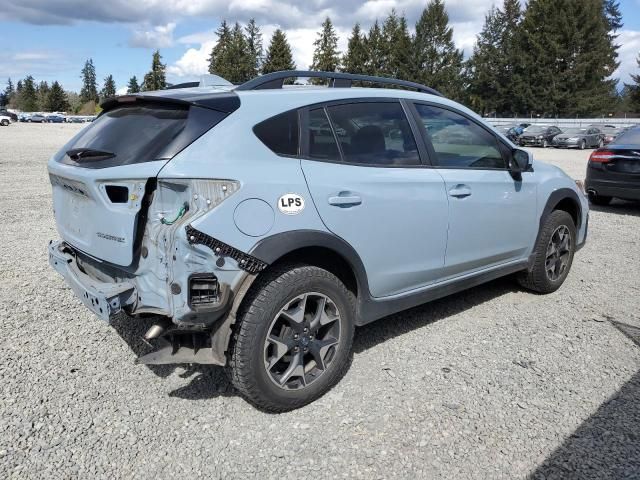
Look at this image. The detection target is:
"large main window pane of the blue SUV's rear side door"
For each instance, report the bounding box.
[327,102,420,166]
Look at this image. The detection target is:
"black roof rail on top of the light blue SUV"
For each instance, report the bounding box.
[236,70,443,97]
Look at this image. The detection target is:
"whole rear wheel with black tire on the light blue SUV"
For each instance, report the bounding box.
[229,264,355,412]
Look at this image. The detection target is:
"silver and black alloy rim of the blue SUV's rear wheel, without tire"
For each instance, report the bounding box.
[264,292,342,390]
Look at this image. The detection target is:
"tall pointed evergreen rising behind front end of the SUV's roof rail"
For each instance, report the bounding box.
[413,0,462,99]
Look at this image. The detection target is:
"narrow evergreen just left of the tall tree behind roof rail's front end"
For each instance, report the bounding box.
[380,9,412,80]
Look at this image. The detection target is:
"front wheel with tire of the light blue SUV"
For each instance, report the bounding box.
[518,210,576,293]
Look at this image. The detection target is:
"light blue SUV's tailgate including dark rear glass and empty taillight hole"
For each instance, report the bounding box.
[49,97,226,266]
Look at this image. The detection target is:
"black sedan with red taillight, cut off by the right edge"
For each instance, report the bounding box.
[585,127,640,205]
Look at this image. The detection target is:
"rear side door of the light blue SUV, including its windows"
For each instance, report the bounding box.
[302,99,447,297]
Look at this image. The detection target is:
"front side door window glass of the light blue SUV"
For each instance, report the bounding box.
[416,105,506,168]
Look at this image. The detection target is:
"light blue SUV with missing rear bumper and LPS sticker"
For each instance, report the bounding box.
[49,72,588,411]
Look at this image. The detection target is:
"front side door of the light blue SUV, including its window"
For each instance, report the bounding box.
[415,103,538,276]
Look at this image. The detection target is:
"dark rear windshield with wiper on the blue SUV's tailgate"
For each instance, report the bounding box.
[57,101,227,168]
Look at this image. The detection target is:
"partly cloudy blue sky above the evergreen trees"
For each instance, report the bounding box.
[0,0,640,93]
